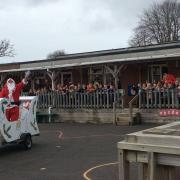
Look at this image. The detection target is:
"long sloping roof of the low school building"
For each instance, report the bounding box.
[0,42,180,72]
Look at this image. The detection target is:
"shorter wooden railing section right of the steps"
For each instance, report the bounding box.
[139,89,180,109]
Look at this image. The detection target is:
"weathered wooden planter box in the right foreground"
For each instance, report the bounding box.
[117,122,180,180]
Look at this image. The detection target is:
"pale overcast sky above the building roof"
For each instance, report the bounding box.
[0,0,167,63]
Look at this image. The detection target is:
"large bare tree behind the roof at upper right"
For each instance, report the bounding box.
[129,0,180,46]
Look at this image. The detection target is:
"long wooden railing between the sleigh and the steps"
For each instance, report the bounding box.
[34,90,123,109]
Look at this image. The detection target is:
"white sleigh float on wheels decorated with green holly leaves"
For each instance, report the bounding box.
[0,96,39,149]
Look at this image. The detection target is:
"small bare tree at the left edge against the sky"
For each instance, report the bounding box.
[0,39,14,57]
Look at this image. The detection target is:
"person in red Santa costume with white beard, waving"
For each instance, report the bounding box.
[0,78,26,121]
